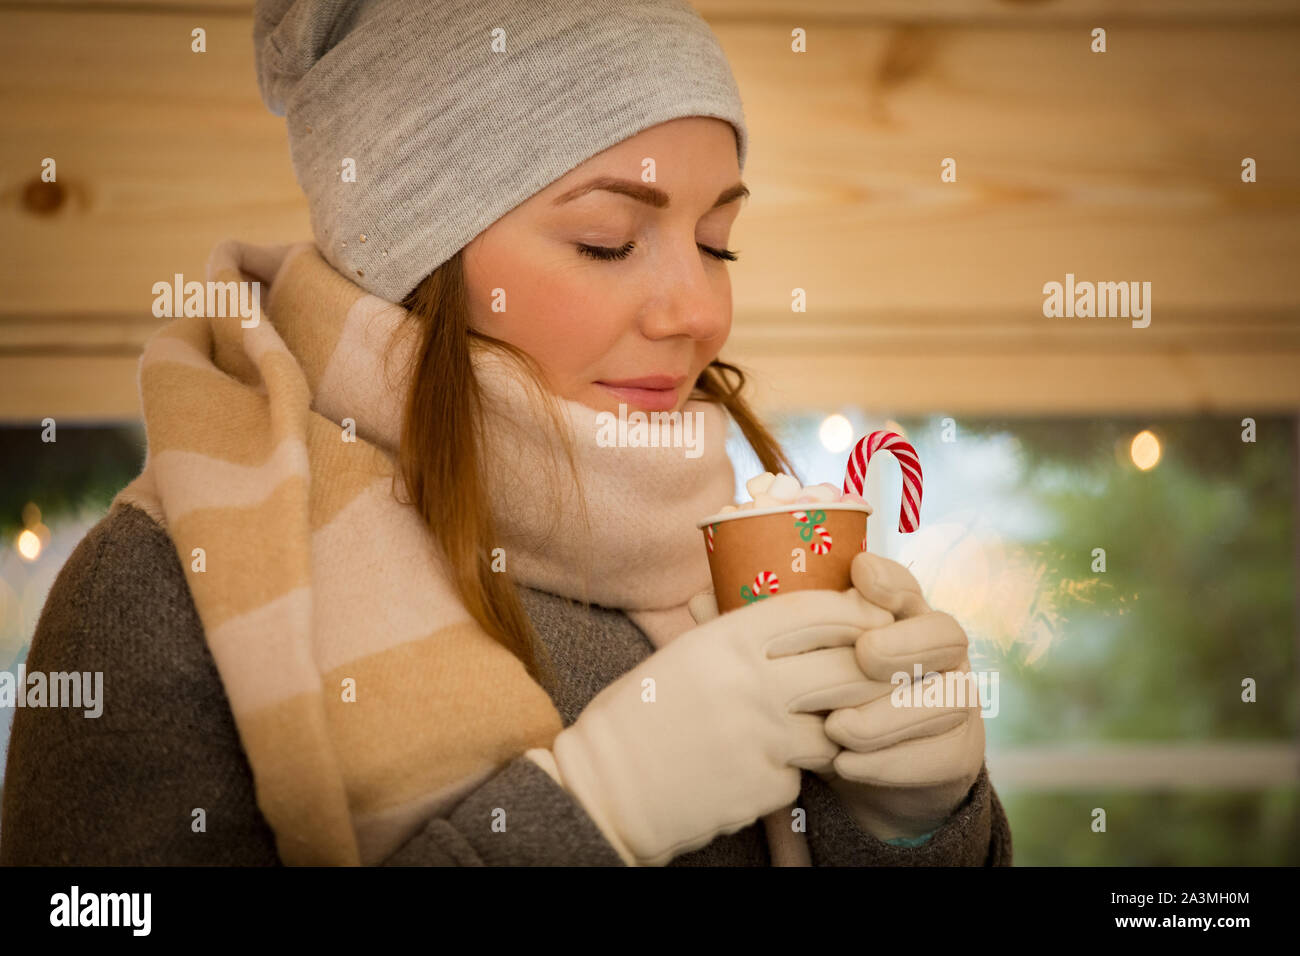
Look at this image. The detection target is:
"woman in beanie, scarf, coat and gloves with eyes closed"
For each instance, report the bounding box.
[0,0,1011,865]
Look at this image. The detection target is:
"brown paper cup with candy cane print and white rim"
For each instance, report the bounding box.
[696,502,871,614]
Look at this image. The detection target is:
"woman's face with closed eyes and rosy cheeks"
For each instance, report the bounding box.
[464,117,748,412]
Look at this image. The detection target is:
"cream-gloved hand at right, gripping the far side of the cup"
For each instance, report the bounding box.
[822,551,984,840]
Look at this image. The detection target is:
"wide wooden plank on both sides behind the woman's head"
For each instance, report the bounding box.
[0,12,1300,313]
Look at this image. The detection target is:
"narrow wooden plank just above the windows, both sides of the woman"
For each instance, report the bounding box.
[0,304,1300,418]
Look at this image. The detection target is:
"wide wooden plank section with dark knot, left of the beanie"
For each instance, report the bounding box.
[0,12,311,315]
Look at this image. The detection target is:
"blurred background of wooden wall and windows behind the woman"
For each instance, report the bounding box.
[0,0,1300,865]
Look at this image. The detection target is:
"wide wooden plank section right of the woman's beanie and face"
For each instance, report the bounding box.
[725,20,1300,312]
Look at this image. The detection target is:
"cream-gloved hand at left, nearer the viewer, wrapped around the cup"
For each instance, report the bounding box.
[528,589,892,866]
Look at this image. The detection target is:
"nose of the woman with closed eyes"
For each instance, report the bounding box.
[641,241,732,339]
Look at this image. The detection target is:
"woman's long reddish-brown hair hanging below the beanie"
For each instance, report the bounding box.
[390,252,794,685]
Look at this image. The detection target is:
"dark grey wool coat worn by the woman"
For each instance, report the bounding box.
[0,507,1011,866]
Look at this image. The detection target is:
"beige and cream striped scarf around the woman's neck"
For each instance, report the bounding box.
[113,242,806,865]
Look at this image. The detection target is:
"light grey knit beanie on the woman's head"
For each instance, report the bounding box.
[254,0,748,302]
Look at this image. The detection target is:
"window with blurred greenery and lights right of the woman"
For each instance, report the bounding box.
[731,410,1300,865]
